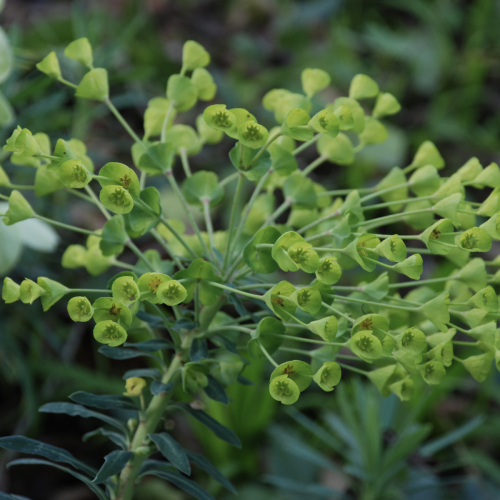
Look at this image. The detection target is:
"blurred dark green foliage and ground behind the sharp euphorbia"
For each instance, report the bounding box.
[0,0,500,500]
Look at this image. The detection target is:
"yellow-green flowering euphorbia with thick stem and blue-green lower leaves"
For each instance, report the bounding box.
[0,38,500,500]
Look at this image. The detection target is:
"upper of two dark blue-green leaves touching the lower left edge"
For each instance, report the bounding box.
[0,436,96,476]
